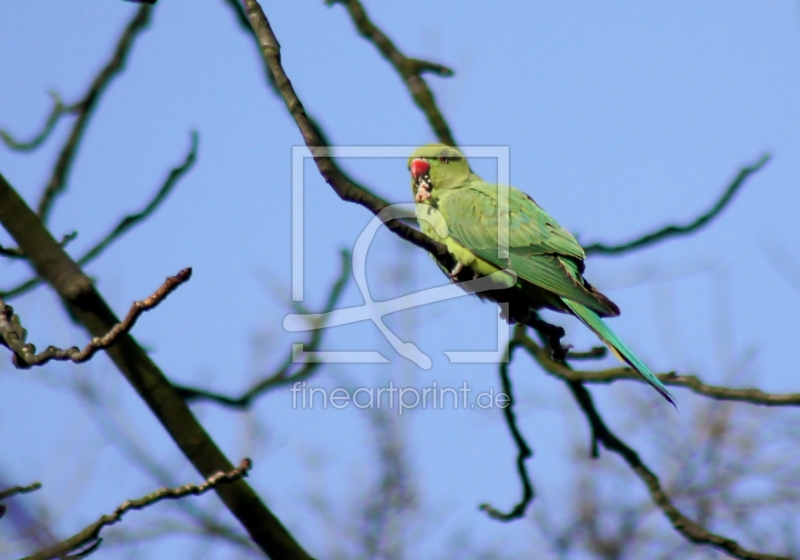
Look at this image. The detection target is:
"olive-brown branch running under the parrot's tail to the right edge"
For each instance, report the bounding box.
[519,334,800,406]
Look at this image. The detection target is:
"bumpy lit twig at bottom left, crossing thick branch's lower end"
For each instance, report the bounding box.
[24,459,253,560]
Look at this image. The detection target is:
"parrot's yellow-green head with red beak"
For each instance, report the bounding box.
[408,144,471,202]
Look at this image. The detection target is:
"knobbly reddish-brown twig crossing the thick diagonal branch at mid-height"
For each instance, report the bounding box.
[0,268,192,369]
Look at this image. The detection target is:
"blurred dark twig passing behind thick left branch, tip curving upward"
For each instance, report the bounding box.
[0,131,198,299]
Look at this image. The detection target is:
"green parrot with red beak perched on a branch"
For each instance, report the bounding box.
[408,144,675,406]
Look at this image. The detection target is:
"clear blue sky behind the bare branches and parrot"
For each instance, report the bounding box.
[0,0,800,559]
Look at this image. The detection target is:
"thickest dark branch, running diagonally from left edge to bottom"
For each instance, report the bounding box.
[0,175,309,559]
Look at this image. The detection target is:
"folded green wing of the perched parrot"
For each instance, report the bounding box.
[437,181,618,315]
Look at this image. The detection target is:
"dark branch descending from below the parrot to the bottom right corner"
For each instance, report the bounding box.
[515,326,789,560]
